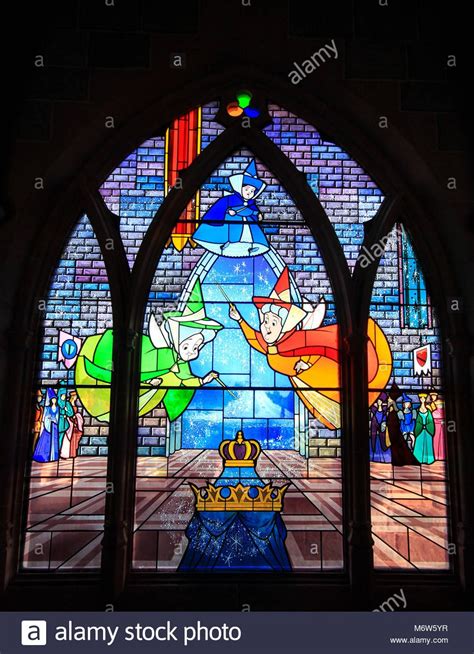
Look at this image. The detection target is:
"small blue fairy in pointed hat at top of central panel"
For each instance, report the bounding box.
[193,160,270,257]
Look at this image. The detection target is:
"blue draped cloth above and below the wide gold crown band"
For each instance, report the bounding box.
[178,468,291,572]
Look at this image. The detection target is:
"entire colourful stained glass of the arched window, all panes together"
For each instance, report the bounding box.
[23,98,447,572]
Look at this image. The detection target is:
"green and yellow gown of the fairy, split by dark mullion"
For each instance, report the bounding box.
[75,329,202,422]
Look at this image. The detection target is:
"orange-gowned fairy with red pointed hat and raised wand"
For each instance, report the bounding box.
[229,267,392,429]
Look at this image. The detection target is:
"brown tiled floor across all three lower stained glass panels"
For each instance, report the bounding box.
[24,450,449,571]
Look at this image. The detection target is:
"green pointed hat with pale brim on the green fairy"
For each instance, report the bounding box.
[163,279,222,347]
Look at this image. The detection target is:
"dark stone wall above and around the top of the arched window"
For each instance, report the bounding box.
[0,0,474,612]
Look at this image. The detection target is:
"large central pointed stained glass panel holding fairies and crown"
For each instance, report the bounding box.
[133,150,343,572]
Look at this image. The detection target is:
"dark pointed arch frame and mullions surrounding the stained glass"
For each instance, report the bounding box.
[0,69,474,610]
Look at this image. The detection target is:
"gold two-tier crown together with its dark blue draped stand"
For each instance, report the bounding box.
[178,431,291,572]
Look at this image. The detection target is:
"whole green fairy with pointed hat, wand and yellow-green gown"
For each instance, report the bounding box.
[75,280,222,422]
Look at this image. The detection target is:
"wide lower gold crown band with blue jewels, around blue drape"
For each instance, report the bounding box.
[189,482,289,511]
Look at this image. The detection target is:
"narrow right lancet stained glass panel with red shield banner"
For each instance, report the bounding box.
[369,225,449,570]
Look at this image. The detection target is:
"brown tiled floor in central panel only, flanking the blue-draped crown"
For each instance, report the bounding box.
[134,450,343,571]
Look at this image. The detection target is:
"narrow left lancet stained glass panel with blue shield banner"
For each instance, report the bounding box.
[22,216,112,570]
